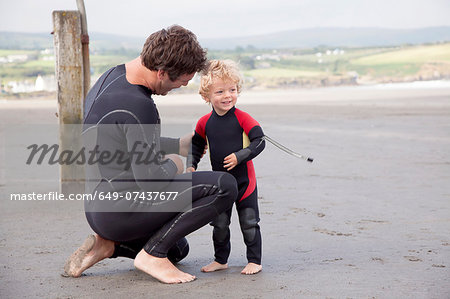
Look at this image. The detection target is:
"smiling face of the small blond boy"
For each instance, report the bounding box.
[205,78,238,115]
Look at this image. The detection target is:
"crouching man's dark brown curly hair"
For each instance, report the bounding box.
[141,25,207,81]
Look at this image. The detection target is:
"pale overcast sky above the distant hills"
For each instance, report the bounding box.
[0,0,450,38]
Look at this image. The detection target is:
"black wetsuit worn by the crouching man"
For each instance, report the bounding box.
[83,65,237,262]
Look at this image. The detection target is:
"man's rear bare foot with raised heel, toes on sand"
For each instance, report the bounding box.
[62,235,114,277]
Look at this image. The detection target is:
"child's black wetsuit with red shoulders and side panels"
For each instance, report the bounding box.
[191,107,265,265]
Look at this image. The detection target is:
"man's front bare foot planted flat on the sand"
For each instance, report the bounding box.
[134,249,195,283]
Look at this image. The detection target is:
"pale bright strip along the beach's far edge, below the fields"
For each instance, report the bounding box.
[0,80,450,109]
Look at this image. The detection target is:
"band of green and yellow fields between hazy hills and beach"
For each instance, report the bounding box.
[0,43,450,87]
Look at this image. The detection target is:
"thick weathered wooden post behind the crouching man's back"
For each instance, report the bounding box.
[53,11,84,194]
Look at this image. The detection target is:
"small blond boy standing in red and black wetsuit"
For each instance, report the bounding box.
[187,60,265,274]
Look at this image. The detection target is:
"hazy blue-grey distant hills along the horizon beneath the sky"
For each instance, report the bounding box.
[0,26,450,51]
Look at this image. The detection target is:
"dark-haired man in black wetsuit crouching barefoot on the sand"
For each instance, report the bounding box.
[64,25,237,283]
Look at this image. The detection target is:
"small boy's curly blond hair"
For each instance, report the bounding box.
[198,59,243,100]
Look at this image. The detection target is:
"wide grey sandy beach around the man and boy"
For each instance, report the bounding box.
[0,83,450,298]
